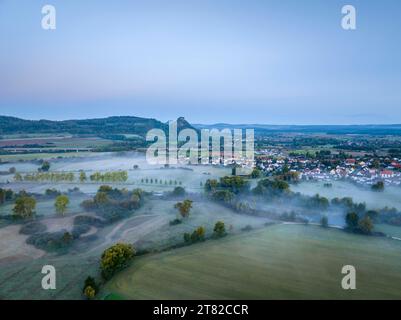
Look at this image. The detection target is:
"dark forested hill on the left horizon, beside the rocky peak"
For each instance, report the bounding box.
[0,116,191,136]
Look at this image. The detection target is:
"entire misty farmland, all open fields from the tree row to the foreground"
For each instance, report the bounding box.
[0,151,401,299]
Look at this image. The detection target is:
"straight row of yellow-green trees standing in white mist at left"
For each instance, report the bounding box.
[14,171,128,182]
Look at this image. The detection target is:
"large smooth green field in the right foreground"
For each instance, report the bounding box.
[104,225,401,299]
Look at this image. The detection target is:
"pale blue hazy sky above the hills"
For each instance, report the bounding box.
[0,0,401,124]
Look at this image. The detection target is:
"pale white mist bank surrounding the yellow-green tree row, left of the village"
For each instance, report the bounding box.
[0,152,231,194]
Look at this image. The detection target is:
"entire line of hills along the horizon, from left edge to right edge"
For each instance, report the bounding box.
[0,116,401,137]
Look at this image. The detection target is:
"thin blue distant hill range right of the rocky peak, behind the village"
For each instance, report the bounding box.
[193,123,401,136]
